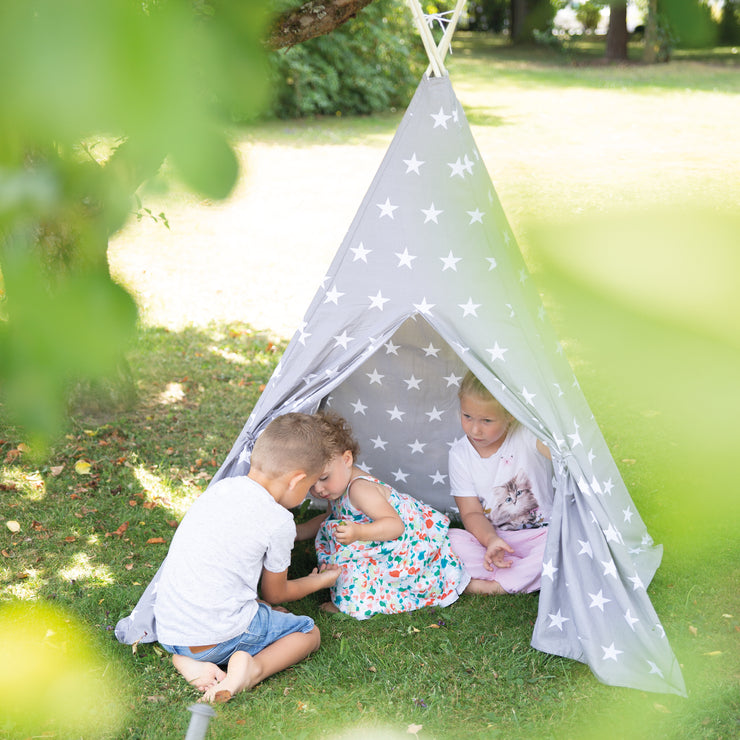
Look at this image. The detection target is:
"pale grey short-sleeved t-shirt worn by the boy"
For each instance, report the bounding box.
[154,476,296,646]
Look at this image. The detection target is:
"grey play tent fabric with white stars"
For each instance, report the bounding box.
[116,76,686,696]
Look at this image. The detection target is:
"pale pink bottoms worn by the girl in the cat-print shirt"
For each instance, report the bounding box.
[448,527,548,594]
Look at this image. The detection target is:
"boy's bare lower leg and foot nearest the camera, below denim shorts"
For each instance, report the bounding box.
[202,627,321,703]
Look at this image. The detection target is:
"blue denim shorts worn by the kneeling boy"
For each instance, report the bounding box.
[160,603,314,665]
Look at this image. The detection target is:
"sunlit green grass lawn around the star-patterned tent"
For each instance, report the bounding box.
[0,34,740,739]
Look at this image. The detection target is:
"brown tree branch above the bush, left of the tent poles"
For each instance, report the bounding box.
[267,0,373,49]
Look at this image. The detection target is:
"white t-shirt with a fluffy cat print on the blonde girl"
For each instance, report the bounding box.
[449,424,553,530]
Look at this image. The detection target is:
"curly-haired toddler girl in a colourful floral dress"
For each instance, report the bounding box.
[311,412,469,619]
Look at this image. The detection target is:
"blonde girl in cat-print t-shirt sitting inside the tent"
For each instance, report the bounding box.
[449,372,553,594]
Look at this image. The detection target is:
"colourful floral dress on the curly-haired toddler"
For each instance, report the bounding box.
[316,476,470,619]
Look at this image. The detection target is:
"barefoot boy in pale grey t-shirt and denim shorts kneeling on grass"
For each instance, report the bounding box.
[154,413,339,703]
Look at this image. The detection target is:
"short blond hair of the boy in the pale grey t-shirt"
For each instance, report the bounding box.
[251,413,330,478]
